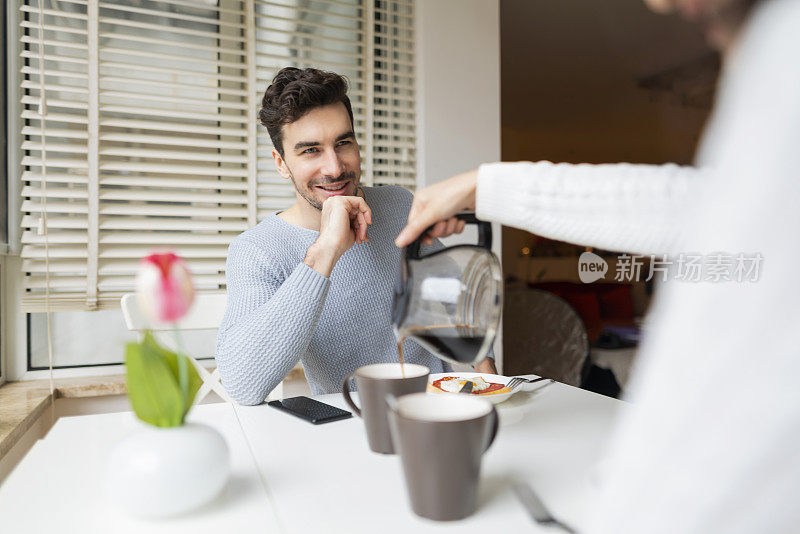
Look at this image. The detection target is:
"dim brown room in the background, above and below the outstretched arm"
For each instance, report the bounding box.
[500,0,720,394]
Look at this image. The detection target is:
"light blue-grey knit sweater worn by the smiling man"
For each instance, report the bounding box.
[216,186,450,404]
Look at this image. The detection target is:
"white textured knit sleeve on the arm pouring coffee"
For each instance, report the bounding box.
[476,162,707,254]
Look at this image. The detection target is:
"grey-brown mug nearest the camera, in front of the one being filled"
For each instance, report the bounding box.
[389,393,499,521]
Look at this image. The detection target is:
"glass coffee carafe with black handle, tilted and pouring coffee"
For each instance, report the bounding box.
[392,213,503,364]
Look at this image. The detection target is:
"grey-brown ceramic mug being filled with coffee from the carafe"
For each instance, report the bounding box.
[342,363,431,454]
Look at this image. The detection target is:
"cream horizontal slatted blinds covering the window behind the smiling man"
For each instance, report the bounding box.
[20,0,416,311]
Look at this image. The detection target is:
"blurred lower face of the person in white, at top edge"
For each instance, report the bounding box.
[645,0,756,50]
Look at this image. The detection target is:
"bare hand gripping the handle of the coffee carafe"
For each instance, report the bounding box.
[395,170,478,247]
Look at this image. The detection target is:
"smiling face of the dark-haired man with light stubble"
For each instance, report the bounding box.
[272,102,361,210]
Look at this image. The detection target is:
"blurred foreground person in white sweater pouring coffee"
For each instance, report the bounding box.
[397,0,800,534]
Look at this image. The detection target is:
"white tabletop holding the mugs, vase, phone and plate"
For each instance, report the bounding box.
[0,378,623,534]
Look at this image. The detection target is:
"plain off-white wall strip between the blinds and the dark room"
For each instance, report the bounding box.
[416,0,502,365]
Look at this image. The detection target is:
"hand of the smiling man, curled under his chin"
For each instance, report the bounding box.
[303,196,372,278]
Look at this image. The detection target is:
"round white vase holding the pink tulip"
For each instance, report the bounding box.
[106,423,230,517]
